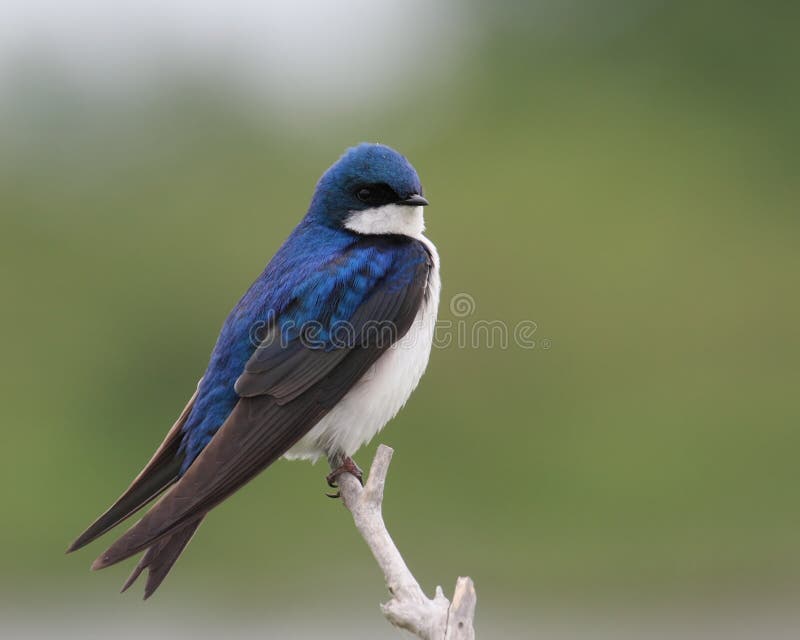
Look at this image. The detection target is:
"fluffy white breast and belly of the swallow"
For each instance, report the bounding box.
[284,237,441,462]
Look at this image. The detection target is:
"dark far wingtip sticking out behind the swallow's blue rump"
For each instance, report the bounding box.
[67,391,197,553]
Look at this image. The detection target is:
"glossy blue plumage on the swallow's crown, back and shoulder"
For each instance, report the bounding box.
[181,144,425,473]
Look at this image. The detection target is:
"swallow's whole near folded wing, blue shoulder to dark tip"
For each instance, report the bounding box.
[89,236,431,568]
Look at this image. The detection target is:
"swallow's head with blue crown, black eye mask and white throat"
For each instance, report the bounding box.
[309,143,428,237]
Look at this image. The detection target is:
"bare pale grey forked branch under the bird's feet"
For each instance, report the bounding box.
[330,445,477,640]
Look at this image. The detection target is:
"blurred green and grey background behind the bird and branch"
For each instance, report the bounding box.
[0,0,800,638]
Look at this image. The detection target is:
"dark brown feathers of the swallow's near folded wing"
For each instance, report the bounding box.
[93,252,430,569]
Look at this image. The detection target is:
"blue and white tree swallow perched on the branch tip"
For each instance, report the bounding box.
[68,143,441,598]
